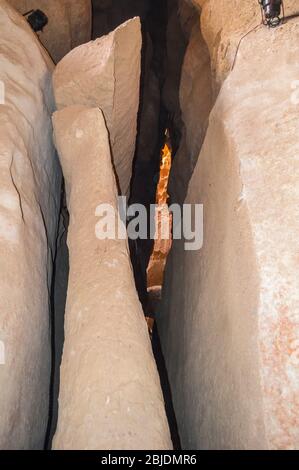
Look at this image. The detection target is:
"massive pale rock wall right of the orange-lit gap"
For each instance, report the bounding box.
[159,0,299,449]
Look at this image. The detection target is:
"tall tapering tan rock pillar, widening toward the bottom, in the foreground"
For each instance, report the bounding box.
[53,106,171,450]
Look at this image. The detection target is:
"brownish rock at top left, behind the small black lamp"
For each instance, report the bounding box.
[9,0,91,62]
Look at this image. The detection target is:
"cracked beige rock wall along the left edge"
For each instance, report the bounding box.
[0,0,60,449]
